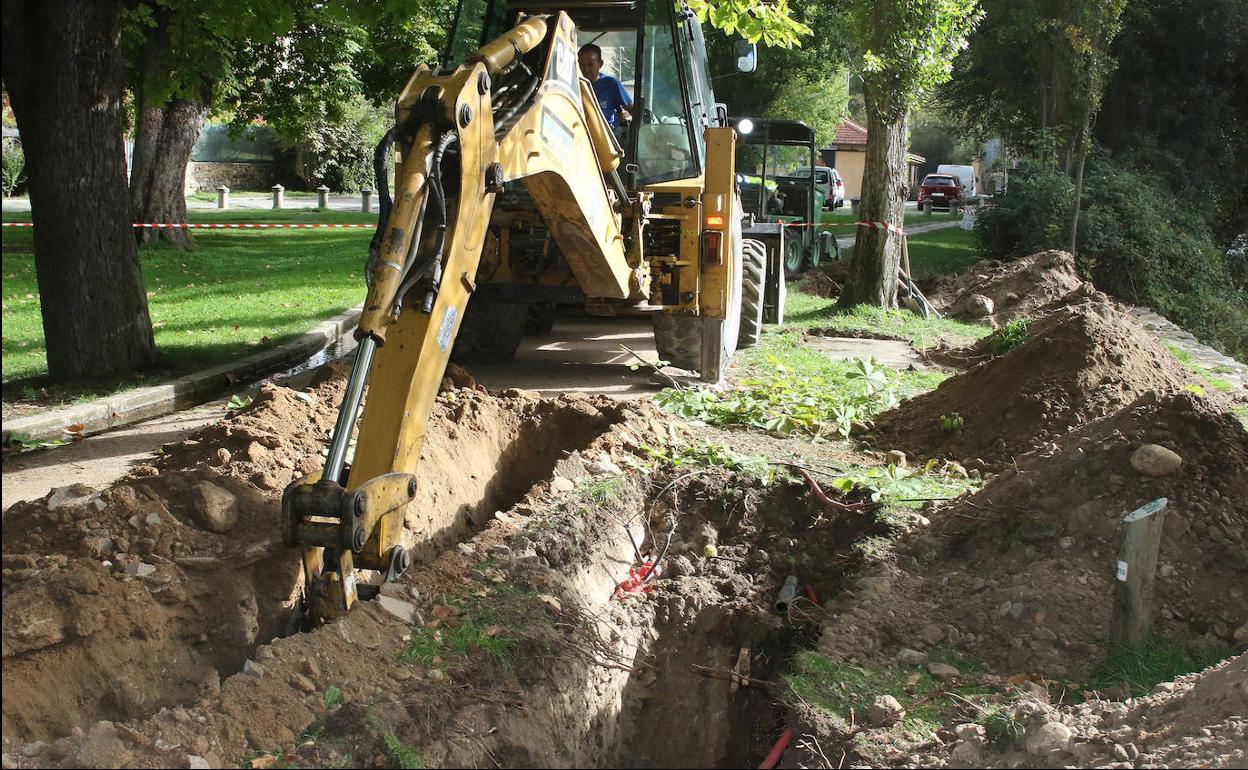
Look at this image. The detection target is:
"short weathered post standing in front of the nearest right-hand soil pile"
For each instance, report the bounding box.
[1109,498,1167,649]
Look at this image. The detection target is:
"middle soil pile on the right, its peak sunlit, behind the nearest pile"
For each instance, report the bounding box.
[872,301,1187,465]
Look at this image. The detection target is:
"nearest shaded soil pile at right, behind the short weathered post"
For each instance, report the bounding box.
[821,393,1248,681]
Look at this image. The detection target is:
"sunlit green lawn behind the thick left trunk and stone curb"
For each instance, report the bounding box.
[2,210,377,402]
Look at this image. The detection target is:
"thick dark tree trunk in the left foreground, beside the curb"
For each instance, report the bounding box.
[4,0,156,382]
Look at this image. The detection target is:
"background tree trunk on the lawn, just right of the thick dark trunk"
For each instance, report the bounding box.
[130,99,208,248]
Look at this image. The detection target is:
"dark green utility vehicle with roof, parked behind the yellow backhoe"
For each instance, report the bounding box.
[730,117,840,318]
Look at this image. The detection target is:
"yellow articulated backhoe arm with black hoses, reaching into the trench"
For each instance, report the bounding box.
[282,12,643,621]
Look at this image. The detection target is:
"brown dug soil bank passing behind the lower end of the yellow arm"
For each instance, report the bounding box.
[2,372,661,761]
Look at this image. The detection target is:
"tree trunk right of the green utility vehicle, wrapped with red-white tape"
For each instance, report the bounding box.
[839,84,906,308]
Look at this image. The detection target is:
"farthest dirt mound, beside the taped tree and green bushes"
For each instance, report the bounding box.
[931,251,1096,323]
